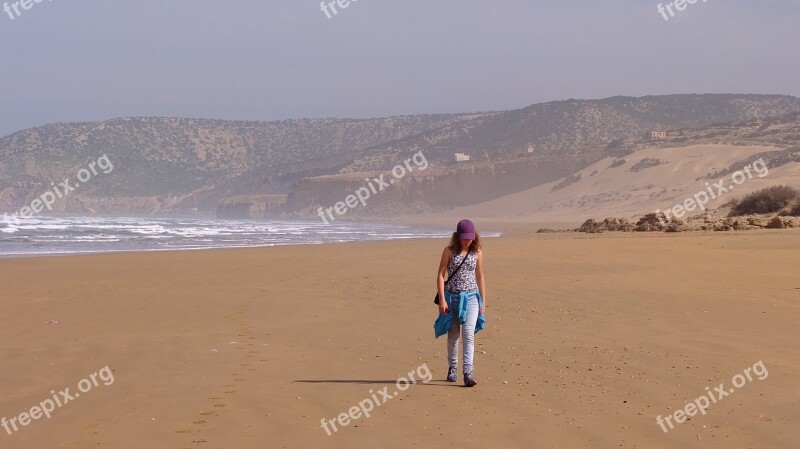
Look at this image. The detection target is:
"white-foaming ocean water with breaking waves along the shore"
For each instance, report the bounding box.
[0,217,462,258]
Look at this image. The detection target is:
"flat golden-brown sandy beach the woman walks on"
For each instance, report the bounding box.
[0,228,800,449]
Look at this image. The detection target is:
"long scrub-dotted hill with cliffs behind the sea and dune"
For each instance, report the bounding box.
[0,94,800,216]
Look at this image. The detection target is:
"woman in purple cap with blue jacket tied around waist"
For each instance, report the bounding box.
[436,220,486,387]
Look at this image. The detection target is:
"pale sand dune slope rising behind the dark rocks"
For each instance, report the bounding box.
[446,145,800,222]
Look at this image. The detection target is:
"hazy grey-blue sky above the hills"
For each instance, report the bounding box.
[0,0,800,135]
